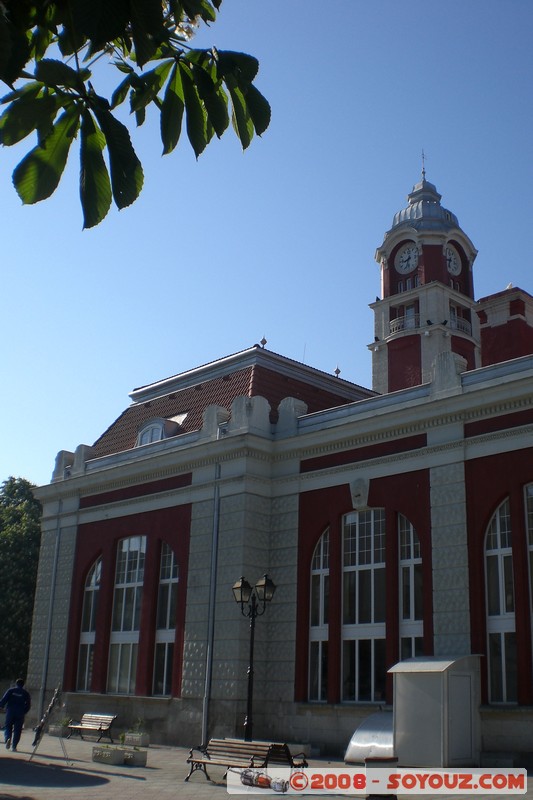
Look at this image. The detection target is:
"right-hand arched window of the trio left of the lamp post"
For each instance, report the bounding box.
[152,543,179,695]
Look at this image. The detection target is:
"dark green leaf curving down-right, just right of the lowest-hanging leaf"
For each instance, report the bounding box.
[95,109,144,208]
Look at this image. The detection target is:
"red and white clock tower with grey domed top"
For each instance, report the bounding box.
[369,170,481,394]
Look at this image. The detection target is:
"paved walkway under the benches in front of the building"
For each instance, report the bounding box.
[0,731,533,800]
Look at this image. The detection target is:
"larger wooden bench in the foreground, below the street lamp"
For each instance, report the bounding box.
[185,739,307,781]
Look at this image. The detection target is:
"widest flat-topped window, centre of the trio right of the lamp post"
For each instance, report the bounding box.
[342,509,386,701]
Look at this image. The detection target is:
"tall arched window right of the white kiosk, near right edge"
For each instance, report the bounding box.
[485,500,517,703]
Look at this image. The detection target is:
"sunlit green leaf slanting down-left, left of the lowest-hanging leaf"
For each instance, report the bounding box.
[13,104,80,205]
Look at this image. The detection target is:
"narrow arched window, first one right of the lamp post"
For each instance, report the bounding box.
[309,528,329,701]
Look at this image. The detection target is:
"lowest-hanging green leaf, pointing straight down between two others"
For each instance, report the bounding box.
[80,110,112,229]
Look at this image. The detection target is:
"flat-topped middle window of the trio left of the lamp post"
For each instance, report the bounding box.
[107,536,146,694]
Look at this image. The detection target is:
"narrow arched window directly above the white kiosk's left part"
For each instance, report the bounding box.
[398,514,423,660]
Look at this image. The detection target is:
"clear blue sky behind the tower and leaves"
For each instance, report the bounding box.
[0,0,533,484]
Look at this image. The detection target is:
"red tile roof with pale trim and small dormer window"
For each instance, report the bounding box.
[92,347,373,458]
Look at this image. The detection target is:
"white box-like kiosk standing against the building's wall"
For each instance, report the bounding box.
[389,655,481,767]
